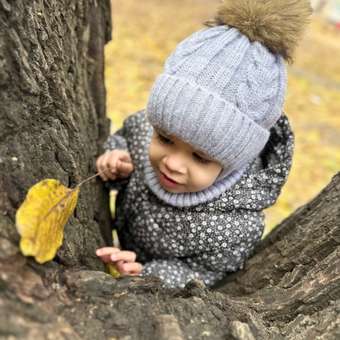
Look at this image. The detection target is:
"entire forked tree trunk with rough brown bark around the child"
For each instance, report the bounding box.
[0,0,340,340]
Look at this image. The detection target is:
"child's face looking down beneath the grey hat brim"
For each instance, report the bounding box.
[149,128,222,193]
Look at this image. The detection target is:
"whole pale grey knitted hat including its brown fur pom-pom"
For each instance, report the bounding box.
[147,0,311,181]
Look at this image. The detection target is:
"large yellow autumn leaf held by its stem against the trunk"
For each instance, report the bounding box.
[16,179,79,263]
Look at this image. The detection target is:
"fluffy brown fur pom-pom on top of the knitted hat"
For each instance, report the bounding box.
[205,0,312,61]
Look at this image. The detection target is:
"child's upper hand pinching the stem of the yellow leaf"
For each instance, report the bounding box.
[96,149,134,181]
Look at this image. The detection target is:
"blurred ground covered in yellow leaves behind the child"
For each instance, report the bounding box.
[105,0,340,236]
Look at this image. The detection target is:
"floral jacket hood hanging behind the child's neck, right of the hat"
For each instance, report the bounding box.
[214,114,294,210]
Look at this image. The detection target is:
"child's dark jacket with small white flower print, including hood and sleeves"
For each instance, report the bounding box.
[106,111,294,287]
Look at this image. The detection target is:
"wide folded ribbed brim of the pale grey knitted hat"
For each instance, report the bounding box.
[147,73,269,180]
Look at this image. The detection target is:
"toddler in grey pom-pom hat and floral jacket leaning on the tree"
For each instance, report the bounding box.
[96,0,311,287]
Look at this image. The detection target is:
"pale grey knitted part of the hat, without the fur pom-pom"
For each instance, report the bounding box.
[147,26,286,185]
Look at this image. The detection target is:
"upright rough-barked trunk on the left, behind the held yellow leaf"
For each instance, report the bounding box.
[0,0,111,269]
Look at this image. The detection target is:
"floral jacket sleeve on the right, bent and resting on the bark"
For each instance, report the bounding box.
[142,209,264,288]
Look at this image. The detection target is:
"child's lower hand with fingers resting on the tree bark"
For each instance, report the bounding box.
[96,247,143,276]
